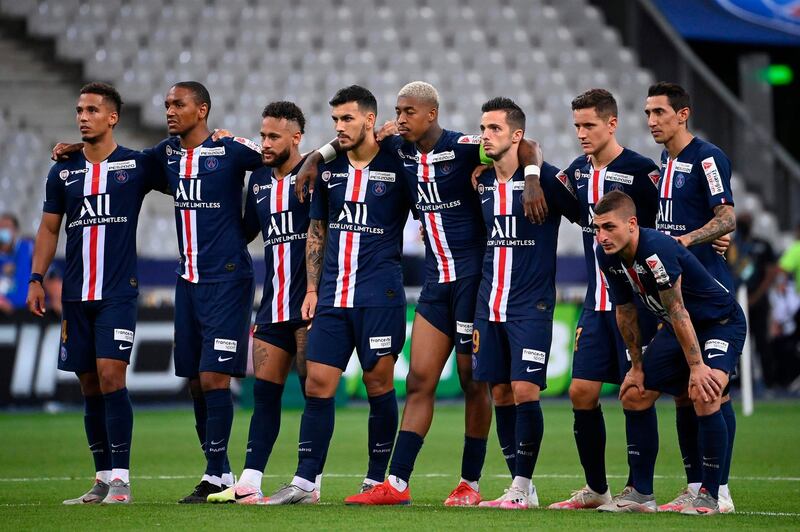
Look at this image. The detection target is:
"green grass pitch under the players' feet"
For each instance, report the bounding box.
[0,399,800,531]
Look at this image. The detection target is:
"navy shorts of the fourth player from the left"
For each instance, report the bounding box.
[306,305,406,371]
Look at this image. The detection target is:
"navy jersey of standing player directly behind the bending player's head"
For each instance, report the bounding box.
[562,148,659,310]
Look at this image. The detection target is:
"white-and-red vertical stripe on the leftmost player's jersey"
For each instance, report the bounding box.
[81,161,111,301]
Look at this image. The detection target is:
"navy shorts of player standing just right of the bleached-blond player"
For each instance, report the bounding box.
[472,319,553,390]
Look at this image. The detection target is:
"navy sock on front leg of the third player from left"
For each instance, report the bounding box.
[244,379,283,473]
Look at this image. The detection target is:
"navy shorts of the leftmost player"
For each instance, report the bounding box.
[58,297,136,373]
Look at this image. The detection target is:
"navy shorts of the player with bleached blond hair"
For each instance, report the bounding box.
[417,275,481,355]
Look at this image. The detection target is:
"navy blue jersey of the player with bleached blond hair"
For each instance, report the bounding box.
[384,130,486,283]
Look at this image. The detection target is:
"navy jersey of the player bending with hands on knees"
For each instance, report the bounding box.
[596,227,737,325]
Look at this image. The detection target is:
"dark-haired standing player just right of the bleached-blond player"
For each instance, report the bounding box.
[473,98,578,510]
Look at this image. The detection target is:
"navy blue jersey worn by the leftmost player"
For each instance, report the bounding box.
[44,146,166,301]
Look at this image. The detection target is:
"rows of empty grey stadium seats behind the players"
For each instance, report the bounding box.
[0,0,775,256]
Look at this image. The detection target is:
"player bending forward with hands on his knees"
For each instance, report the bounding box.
[594,191,746,515]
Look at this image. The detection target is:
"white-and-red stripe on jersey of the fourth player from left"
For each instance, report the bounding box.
[333,166,369,308]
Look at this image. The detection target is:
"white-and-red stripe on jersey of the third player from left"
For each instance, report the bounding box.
[269,175,292,323]
